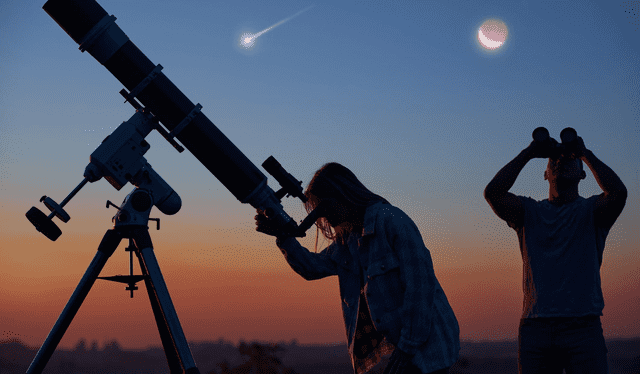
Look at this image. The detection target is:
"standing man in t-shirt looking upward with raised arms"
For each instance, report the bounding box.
[484,133,627,374]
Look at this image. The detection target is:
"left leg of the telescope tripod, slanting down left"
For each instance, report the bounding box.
[27,230,122,374]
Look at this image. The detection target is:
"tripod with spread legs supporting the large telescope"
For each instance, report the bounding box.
[27,225,200,374]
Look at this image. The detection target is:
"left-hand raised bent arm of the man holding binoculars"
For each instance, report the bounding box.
[484,143,540,226]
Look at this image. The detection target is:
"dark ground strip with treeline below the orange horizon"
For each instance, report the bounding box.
[0,339,640,374]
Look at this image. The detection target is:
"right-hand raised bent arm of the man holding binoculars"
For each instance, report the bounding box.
[578,142,627,228]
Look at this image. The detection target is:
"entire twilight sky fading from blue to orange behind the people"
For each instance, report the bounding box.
[0,0,640,348]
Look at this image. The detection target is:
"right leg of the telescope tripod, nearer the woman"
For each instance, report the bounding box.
[134,227,200,374]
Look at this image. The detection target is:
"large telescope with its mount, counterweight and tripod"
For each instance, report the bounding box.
[26,0,323,374]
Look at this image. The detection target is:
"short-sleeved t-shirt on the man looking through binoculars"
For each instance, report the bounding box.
[509,196,609,318]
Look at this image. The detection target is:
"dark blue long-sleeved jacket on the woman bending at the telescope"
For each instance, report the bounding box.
[276,203,460,373]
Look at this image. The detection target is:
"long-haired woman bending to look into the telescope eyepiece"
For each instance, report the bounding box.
[255,162,460,374]
